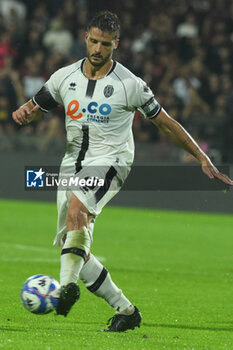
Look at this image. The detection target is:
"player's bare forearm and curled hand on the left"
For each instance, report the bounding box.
[12,100,43,125]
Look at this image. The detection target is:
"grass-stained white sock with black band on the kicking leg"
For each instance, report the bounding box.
[60,228,91,285]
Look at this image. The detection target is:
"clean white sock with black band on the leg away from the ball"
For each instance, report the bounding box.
[79,254,134,315]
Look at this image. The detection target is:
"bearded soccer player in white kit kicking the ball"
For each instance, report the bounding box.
[13,11,233,332]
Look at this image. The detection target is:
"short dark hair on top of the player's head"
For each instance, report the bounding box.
[87,11,120,39]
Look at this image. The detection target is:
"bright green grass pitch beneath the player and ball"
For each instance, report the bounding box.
[0,200,233,350]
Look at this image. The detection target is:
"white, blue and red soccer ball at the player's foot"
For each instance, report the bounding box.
[21,275,60,314]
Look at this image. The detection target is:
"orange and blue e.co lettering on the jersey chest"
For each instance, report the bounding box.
[66,100,112,120]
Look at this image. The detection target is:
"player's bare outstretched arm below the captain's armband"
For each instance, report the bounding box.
[151,108,233,185]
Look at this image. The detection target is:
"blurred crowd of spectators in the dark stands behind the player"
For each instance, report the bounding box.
[0,0,233,162]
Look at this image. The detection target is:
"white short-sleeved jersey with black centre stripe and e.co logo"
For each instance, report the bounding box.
[33,59,161,165]
